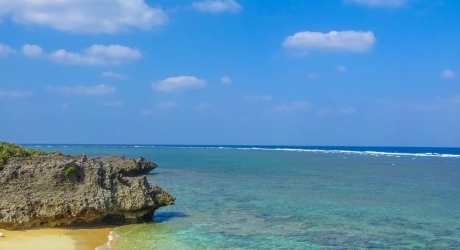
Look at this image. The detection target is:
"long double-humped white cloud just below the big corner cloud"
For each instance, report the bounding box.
[49,44,142,65]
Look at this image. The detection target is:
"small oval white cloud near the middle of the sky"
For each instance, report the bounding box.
[152,76,206,93]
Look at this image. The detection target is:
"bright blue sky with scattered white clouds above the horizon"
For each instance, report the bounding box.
[0,0,460,147]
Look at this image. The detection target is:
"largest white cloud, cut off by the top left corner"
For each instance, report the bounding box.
[0,0,167,33]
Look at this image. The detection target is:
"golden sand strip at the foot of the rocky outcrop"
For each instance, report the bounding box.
[0,228,113,250]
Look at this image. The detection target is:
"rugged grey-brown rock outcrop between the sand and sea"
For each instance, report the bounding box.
[0,153,174,229]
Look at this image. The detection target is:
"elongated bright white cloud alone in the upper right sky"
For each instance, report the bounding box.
[283,30,376,53]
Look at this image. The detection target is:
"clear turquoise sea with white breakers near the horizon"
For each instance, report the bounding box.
[24,144,460,250]
